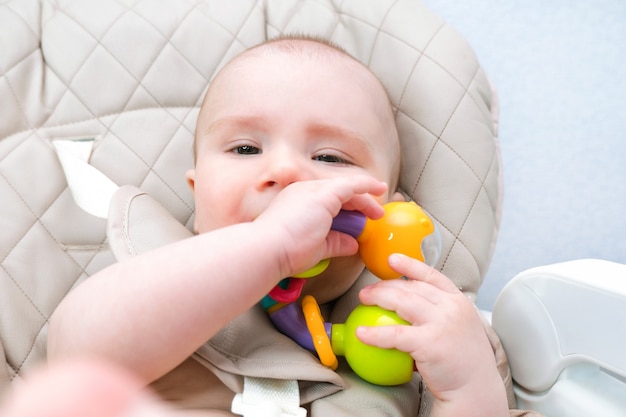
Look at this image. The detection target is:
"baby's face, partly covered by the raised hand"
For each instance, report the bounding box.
[189,45,399,302]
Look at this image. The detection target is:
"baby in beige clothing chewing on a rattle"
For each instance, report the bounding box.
[48,37,509,416]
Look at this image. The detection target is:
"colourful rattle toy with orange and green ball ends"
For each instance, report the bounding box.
[261,202,441,385]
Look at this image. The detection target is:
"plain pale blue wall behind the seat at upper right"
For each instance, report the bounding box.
[423,0,626,310]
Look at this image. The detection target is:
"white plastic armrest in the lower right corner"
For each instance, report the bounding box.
[492,259,626,417]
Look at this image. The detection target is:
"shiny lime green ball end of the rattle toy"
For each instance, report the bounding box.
[331,305,414,386]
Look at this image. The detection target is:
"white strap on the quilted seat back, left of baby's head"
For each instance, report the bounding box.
[52,138,119,219]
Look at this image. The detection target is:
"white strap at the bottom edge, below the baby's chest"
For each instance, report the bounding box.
[231,377,307,417]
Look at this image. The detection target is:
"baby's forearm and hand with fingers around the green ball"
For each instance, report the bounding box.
[357,255,509,417]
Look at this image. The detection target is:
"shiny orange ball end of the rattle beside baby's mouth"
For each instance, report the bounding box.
[357,202,435,279]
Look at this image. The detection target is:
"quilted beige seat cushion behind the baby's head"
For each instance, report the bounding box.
[0,0,501,386]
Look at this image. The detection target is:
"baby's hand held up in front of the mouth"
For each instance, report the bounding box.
[256,175,387,276]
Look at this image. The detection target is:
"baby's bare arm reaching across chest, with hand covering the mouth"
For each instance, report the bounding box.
[48,176,386,382]
